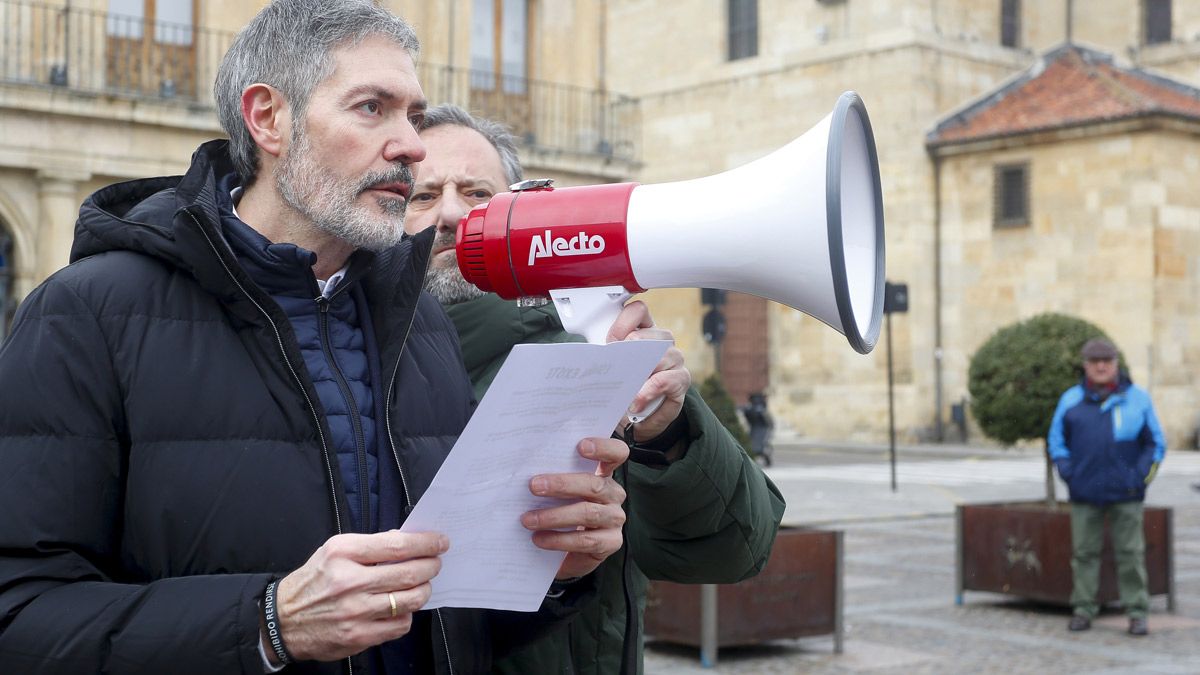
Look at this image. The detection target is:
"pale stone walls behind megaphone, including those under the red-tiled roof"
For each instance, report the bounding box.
[608,0,1200,447]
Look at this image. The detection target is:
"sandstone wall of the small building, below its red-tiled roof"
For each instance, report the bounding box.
[942,126,1200,447]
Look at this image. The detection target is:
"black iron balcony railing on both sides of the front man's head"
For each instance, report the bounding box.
[0,0,641,161]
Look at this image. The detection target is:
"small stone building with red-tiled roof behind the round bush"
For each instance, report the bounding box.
[928,46,1200,447]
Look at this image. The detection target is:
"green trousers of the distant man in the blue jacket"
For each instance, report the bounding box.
[1070,502,1150,619]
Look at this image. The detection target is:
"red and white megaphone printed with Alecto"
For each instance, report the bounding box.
[456,91,884,354]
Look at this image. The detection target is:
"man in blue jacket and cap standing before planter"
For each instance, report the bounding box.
[1049,338,1166,635]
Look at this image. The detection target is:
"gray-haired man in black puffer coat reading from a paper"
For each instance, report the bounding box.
[0,0,628,675]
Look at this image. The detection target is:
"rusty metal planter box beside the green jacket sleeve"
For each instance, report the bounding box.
[646,527,842,652]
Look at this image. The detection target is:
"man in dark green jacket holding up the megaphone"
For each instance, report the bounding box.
[404,106,785,675]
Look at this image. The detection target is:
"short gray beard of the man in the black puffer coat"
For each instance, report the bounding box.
[275,127,413,251]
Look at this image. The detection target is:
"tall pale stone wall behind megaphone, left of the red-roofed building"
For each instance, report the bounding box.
[611,2,1030,440]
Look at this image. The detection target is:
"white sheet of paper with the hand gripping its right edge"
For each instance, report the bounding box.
[401,340,671,611]
